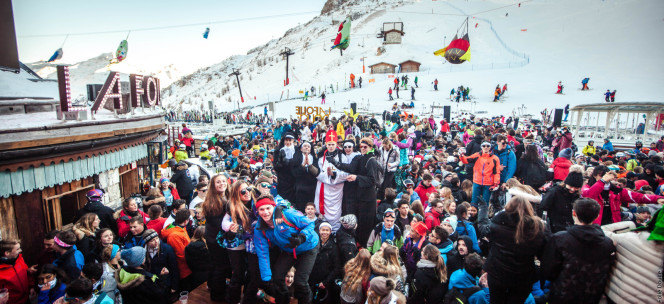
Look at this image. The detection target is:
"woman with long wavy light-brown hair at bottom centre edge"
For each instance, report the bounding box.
[341,248,371,304]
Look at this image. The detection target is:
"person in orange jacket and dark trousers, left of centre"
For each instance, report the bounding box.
[161,209,192,291]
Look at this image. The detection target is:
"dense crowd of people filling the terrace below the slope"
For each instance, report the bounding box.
[0,112,664,304]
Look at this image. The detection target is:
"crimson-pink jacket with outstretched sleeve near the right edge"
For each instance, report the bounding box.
[582,180,664,225]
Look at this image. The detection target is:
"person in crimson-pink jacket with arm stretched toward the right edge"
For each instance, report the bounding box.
[582,165,664,225]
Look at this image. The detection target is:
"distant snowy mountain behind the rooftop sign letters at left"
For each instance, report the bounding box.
[26,53,184,100]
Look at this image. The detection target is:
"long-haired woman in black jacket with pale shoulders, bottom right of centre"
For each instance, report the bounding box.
[409,244,447,303]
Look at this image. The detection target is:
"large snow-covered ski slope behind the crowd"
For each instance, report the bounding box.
[162,0,664,117]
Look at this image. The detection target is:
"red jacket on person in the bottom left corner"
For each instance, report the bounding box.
[0,254,31,303]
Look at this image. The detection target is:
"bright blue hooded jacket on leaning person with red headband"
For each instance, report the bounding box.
[254,209,318,281]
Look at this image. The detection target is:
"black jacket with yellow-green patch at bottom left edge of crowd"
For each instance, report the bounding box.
[115,267,170,304]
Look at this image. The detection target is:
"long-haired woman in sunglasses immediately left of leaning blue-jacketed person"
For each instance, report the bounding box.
[217,180,258,303]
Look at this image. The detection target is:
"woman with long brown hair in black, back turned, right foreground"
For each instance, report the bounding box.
[484,196,545,304]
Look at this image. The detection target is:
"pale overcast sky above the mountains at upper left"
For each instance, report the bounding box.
[12,0,325,69]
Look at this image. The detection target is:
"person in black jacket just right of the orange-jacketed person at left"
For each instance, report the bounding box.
[184,226,210,289]
